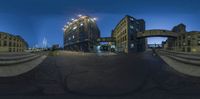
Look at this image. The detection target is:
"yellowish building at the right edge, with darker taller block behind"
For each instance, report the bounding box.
[164,24,200,53]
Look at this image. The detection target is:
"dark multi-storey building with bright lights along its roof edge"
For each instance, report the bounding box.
[63,15,100,51]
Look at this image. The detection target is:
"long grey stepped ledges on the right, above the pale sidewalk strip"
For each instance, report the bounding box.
[156,50,200,66]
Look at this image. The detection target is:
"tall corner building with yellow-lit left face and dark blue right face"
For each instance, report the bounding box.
[112,15,147,53]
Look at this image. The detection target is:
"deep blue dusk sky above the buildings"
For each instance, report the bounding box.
[0,0,200,47]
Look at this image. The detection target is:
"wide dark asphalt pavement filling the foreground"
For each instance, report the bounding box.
[0,52,200,99]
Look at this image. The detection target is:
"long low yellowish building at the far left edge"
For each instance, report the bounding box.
[0,32,28,52]
